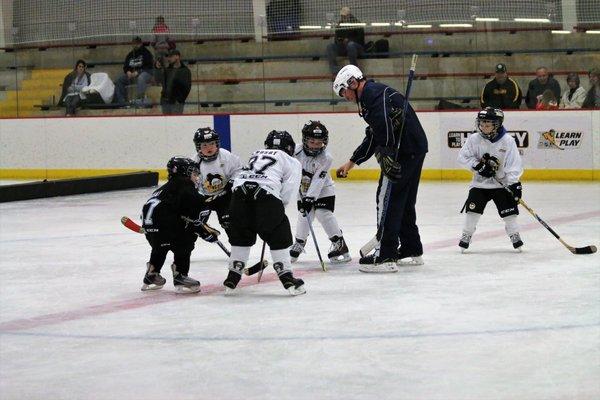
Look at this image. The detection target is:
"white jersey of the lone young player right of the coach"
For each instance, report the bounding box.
[458,129,523,189]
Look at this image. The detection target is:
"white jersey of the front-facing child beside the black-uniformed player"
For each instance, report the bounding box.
[191,149,242,196]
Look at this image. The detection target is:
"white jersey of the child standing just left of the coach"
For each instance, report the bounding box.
[294,144,335,199]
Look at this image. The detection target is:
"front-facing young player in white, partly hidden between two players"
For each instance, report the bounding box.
[194,127,242,236]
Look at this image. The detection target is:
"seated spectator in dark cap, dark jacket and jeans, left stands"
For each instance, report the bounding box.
[115,36,153,105]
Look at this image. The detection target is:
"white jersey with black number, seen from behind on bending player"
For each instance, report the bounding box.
[233,149,302,205]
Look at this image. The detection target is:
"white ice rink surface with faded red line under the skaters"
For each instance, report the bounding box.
[0,182,600,400]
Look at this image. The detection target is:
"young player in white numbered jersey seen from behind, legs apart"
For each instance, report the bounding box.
[223,131,305,296]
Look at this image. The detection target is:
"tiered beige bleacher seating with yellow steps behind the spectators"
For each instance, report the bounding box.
[0,31,600,117]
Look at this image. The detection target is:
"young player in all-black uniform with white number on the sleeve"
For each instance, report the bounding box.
[142,157,219,293]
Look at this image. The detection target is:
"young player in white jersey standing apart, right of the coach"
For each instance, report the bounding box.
[458,107,523,252]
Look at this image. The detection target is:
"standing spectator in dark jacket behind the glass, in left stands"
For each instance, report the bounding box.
[154,49,192,114]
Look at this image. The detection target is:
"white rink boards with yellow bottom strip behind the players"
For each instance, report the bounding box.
[0,111,600,180]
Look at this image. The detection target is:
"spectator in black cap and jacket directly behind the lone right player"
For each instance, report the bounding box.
[481,63,523,110]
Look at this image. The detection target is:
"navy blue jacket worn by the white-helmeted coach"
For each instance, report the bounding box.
[350,80,428,164]
